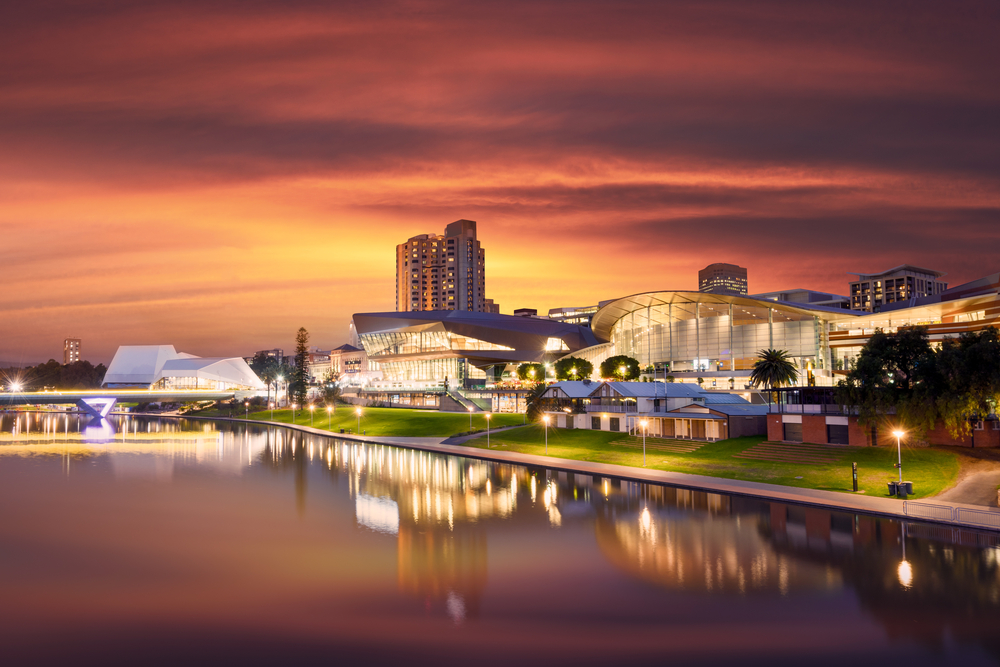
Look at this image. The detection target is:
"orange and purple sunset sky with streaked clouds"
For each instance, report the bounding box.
[0,0,1000,363]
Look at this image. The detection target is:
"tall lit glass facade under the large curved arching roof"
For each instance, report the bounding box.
[611,301,828,371]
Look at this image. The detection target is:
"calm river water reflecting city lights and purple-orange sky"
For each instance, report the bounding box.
[0,413,1000,666]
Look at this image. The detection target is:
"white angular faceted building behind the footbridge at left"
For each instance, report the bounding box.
[104,345,265,391]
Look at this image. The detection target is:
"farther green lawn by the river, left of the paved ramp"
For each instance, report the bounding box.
[204,405,524,438]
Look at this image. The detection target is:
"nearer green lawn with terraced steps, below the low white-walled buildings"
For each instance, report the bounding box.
[465,424,959,498]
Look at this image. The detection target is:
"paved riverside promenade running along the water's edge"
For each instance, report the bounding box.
[172,415,1000,530]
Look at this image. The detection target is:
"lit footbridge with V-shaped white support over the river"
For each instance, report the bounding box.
[0,389,256,419]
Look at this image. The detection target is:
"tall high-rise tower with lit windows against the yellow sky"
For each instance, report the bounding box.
[396,220,499,312]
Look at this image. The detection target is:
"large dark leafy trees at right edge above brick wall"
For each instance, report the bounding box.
[837,327,1000,437]
